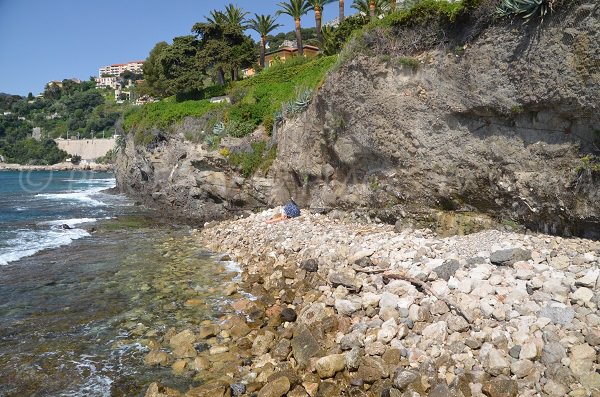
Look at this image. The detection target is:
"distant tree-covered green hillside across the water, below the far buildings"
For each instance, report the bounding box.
[0,80,129,165]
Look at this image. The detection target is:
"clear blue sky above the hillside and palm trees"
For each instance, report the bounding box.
[0,0,354,95]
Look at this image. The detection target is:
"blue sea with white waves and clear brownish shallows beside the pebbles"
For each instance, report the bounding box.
[0,171,238,397]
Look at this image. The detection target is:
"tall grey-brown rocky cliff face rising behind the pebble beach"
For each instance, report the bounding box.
[117,3,600,238]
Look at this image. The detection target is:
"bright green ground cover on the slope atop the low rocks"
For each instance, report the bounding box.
[123,56,335,147]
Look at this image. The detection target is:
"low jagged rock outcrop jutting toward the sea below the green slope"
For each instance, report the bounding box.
[115,118,282,222]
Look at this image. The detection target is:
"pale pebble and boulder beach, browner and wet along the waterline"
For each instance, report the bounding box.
[145,211,600,397]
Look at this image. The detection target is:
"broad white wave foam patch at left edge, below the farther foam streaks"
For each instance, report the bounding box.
[0,229,90,265]
